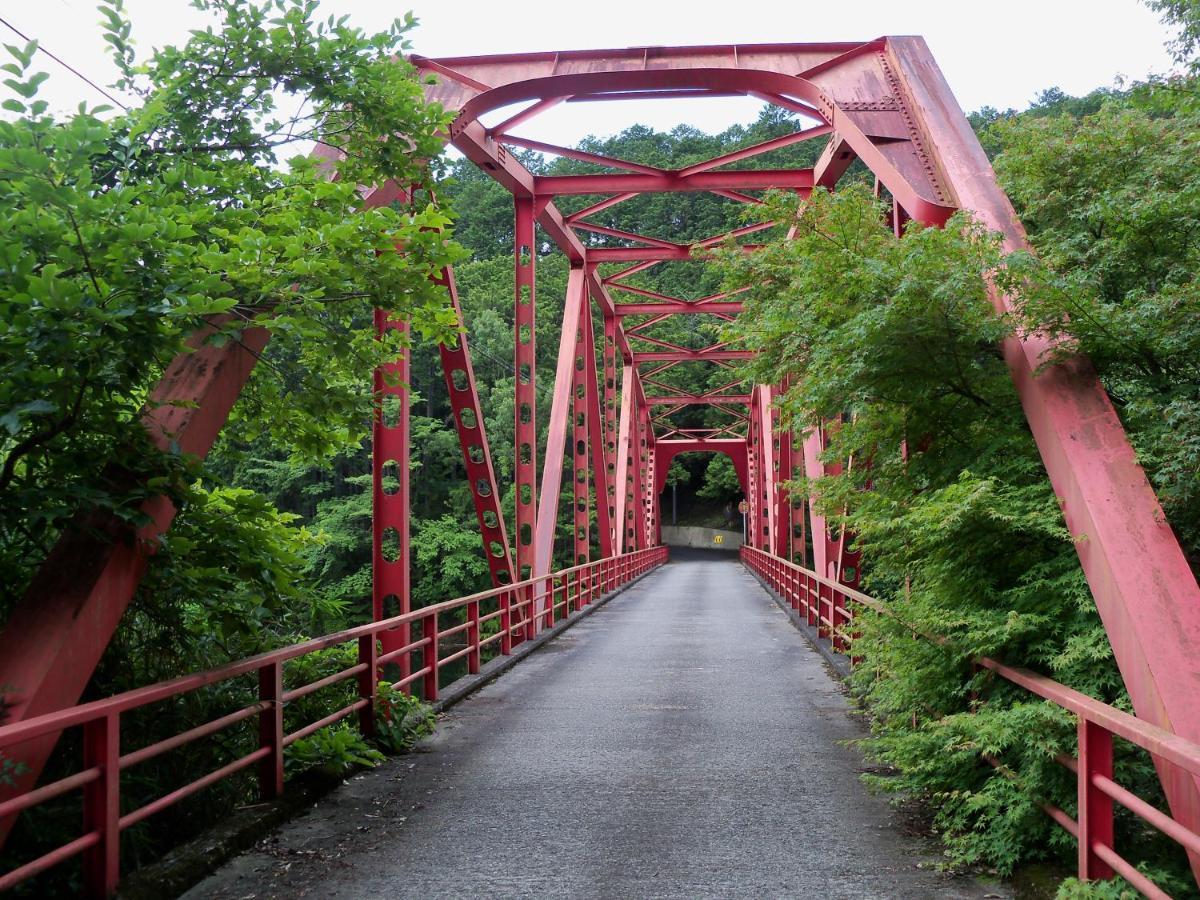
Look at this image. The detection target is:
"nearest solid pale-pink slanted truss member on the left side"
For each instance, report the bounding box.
[533,266,588,592]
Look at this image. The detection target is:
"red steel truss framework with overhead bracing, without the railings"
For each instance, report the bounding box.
[0,37,1200,888]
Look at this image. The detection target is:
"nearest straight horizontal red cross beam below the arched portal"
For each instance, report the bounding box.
[534,167,814,197]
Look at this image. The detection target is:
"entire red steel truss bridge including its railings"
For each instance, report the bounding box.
[0,37,1200,896]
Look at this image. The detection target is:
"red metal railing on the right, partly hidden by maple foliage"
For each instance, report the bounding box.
[742,546,1200,900]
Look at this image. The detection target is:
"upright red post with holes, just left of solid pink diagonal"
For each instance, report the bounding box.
[512,197,538,588]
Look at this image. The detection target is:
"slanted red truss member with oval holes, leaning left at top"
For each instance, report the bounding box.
[437,269,512,588]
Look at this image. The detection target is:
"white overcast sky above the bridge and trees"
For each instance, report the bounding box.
[0,0,1170,144]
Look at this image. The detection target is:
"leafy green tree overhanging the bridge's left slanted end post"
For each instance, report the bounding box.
[0,0,456,609]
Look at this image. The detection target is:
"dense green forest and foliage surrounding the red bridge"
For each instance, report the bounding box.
[0,0,1200,894]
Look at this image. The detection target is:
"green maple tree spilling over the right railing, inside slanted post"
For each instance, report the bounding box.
[726,183,1186,888]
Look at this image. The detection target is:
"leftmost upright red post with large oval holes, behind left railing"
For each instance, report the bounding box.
[371,310,412,677]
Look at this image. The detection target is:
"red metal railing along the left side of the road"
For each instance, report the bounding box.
[0,547,667,896]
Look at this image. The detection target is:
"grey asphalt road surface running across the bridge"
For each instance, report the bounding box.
[187,556,997,898]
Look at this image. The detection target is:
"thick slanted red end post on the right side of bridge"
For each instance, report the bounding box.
[884,37,1200,875]
